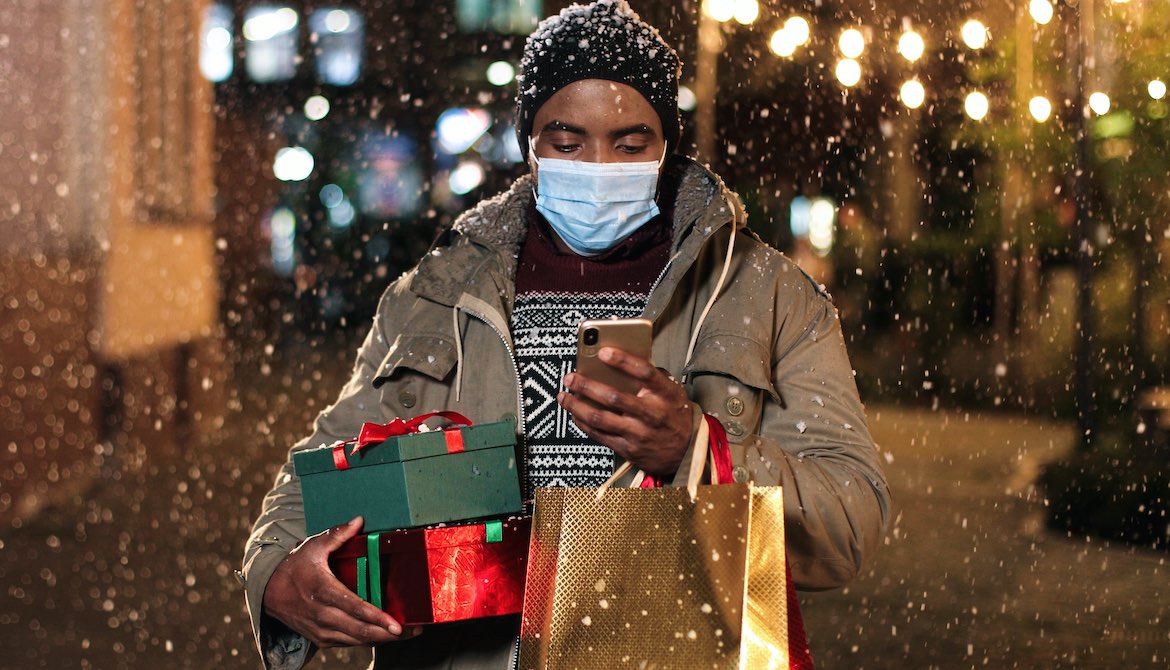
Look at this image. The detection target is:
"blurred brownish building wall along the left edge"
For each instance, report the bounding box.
[0,0,219,527]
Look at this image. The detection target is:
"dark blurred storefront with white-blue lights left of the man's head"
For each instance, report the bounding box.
[201,0,550,337]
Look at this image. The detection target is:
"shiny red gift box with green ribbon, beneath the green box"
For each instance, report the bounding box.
[329,516,532,626]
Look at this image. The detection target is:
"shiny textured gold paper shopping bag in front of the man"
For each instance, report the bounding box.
[519,418,811,670]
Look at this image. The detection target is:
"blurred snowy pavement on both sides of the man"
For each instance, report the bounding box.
[0,336,1170,670]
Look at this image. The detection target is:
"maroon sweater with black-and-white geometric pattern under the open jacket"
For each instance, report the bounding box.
[511,212,670,499]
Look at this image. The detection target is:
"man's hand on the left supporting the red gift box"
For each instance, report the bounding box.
[263,517,421,648]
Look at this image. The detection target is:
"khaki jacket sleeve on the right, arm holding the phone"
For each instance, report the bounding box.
[748,277,890,589]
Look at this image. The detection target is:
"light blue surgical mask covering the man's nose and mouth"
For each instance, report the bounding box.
[529,139,666,256]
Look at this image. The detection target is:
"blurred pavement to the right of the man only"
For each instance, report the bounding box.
[803,406,1170,670]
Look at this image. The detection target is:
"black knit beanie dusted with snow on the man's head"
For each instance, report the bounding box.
[516,0,682,158]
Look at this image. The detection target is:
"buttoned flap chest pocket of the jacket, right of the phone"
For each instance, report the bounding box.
[683,333,779,442]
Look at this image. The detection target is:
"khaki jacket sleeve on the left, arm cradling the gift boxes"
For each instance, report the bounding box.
[242,291,392,670]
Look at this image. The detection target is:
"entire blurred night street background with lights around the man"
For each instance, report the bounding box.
[0,0,1170,670]
